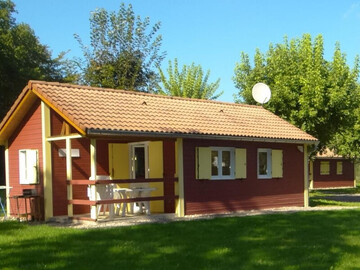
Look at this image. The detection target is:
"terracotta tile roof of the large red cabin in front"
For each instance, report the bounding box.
[20,81,317,142]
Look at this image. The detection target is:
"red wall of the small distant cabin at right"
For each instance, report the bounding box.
[313,159,355,188]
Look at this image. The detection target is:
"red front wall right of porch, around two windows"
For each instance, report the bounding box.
[183,139,304,215]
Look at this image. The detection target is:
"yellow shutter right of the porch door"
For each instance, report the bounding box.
[149,141,163,178]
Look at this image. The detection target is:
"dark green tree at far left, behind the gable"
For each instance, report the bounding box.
[0,0,62,119]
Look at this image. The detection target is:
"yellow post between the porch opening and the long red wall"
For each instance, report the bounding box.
[176,138,185,217]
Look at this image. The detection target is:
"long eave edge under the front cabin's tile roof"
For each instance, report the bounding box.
[86,128,319,144]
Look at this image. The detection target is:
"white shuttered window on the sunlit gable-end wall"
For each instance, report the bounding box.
[19,150,39,184]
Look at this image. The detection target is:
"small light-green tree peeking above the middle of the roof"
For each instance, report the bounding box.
[158,58,223,99]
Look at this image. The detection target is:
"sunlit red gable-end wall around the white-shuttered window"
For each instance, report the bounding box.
[9,100,44,218]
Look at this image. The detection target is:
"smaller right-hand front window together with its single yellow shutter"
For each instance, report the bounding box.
[257,148,283,179]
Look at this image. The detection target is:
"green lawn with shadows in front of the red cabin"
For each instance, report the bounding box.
[0,210,360,270]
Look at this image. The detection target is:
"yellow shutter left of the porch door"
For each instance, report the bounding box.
[109,143,130,179]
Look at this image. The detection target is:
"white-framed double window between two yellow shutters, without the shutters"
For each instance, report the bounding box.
[211,147,234,179]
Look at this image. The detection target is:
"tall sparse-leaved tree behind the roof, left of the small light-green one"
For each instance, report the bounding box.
[75,3,165,92]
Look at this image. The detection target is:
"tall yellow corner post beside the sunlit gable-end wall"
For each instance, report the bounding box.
[41,102,53,220]
